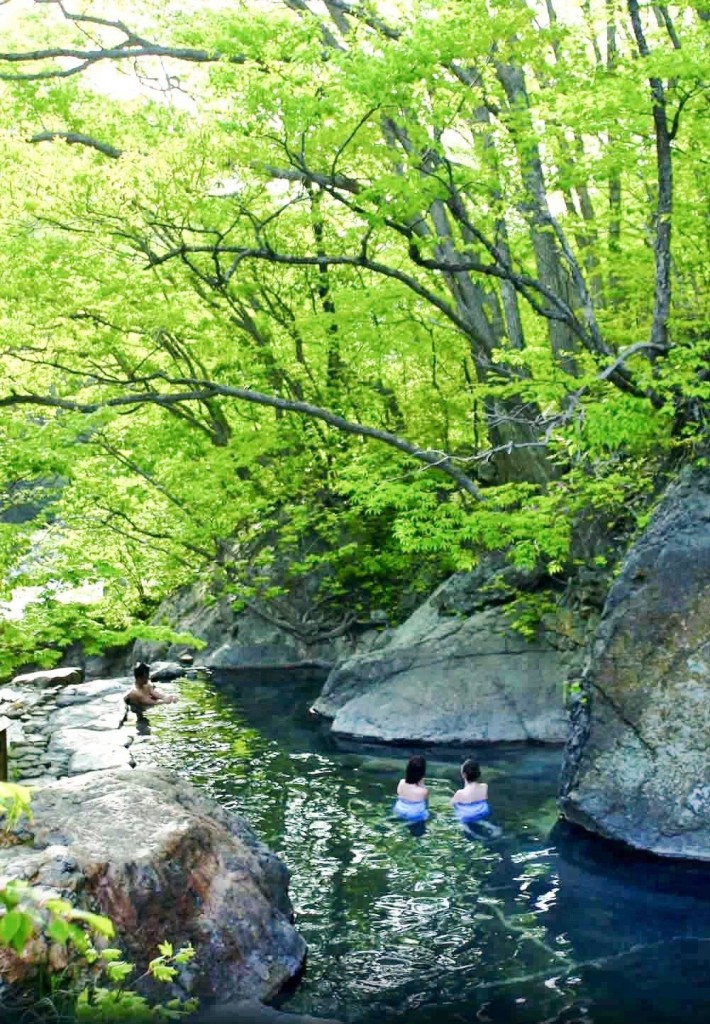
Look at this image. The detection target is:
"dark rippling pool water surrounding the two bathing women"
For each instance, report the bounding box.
[139,679,710,1024]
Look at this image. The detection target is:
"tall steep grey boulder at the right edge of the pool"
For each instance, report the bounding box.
[560,471,710,860]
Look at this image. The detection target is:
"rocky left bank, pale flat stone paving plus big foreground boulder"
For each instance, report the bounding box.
[0,668,346,1024]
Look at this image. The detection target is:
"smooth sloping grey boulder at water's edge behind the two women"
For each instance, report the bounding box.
[315,573,583,744]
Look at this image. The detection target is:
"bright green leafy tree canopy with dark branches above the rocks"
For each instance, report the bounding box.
[0,0,710,670]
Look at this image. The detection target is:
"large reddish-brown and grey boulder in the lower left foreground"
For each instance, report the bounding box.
[0,769,305,1001]
